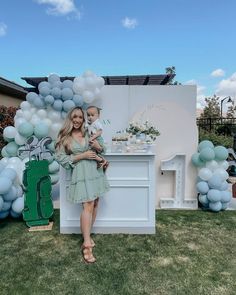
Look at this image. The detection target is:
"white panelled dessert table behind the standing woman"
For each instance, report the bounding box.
[60,153,156,234]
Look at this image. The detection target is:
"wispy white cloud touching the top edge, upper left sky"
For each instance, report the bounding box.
[35,0,80,17]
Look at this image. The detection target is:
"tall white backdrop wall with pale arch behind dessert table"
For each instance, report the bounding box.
[94,85,198,208]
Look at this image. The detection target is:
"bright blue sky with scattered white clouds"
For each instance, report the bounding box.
[0,0,236,107]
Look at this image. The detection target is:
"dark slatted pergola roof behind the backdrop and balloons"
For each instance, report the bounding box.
[21,74,175,87]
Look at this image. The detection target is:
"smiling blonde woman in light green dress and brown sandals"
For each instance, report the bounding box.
[56,107,109,263]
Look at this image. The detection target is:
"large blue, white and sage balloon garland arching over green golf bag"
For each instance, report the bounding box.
[0,71,105,218]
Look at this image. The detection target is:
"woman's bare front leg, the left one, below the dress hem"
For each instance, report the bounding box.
[80,201,94,247]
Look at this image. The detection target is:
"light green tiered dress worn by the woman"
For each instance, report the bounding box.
[56,134,109,203]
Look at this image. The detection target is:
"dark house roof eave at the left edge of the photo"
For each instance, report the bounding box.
[0,77,28,99]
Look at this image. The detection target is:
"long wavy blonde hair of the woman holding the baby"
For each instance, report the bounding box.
[55,107,85,154]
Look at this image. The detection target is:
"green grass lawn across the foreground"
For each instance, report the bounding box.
[0,210,236,295]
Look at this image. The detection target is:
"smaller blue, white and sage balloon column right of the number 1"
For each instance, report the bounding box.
[192,140,232,212]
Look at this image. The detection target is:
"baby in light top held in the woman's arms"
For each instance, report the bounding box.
[86,106,109,171]
